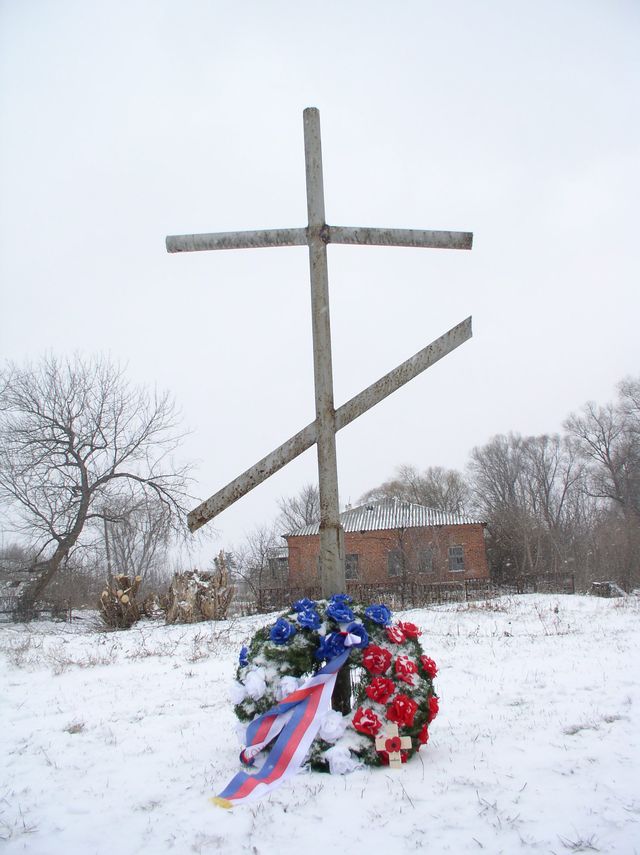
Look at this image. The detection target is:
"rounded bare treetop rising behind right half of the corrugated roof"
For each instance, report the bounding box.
[360,464,470,514]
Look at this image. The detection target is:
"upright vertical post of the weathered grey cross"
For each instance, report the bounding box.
[303,107,345,597]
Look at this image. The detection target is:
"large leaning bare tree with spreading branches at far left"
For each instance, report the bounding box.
[0,356,189,616]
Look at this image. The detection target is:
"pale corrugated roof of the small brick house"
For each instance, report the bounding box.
[283,499,483,537]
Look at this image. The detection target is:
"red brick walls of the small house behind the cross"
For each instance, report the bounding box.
[287,524,489,585]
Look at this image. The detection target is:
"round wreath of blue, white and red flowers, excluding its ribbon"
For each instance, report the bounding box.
[233,594,438,774]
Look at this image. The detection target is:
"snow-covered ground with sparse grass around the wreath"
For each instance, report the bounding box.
[0,595,640,855]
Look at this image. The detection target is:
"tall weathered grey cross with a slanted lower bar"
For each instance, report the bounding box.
[166,107,473,597]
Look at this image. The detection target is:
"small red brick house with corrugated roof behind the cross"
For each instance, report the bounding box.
[283,499,489,586]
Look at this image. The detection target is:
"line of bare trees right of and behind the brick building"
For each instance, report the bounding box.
[362,378,640,590]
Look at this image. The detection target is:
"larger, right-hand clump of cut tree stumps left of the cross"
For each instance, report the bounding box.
[166,552,234,623]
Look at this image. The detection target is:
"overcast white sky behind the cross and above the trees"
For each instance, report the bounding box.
[0,0,640,552]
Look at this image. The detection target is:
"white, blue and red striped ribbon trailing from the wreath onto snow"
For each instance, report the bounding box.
[212,648,352,808]
